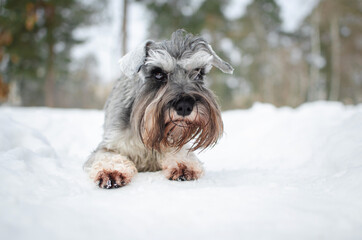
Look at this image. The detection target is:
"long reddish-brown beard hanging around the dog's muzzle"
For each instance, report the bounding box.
[131,86,223,152]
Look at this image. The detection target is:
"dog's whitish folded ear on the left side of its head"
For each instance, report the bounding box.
[119,40,153,78]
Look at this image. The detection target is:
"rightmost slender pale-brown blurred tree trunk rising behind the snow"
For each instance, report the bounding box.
[329,15,341,101]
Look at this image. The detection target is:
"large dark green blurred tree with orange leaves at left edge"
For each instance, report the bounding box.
[0,0,103,106]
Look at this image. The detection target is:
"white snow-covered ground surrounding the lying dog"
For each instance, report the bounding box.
[0,102,362,239]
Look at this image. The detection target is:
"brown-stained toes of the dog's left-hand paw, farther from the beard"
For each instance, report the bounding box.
[96,170,131,189]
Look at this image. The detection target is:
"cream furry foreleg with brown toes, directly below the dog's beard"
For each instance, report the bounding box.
[160,149,204,181]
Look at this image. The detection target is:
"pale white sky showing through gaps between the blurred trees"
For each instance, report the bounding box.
[73,0,318,82]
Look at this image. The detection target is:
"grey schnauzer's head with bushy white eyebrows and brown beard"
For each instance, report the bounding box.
[120,30,233,151]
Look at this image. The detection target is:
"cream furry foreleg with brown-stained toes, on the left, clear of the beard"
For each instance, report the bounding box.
[84,149,137,189]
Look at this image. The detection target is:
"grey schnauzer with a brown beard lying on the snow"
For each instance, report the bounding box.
[84,29,234,189]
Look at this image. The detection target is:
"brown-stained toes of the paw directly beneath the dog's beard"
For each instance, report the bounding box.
[163,162,204,181]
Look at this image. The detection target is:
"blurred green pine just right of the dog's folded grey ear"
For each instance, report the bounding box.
[233,0,281,105]
